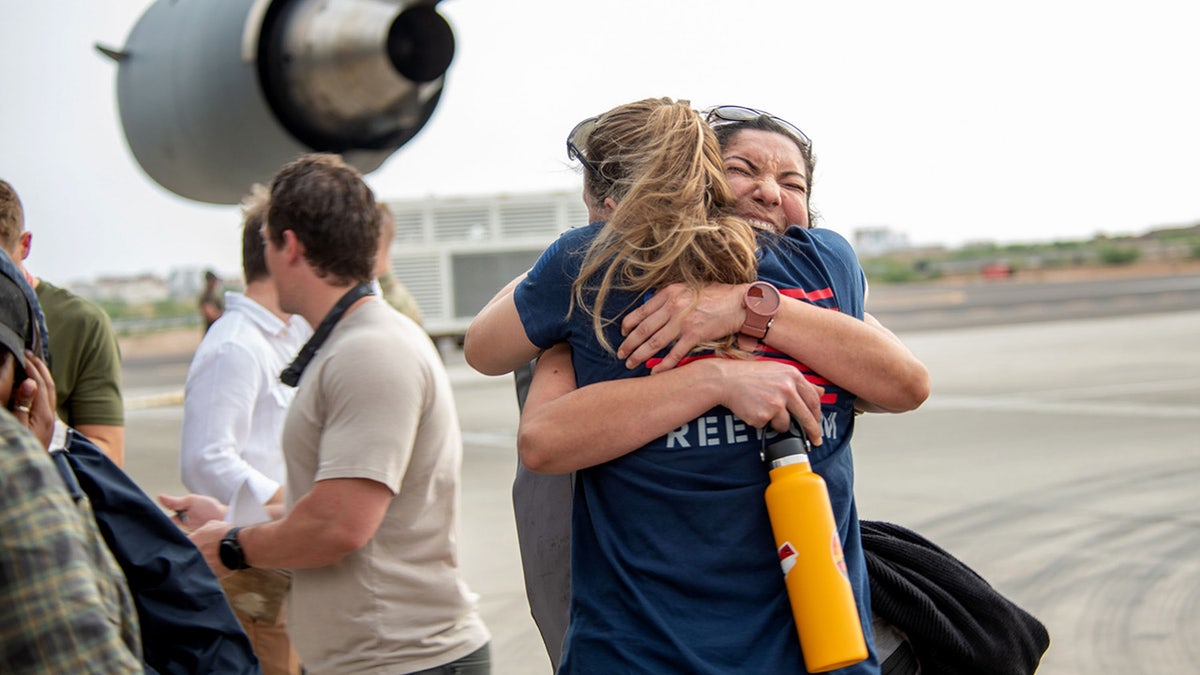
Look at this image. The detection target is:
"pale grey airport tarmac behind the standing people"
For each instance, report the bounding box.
[119,276,1200,675]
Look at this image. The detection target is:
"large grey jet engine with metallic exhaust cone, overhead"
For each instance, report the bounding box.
[100,0,455,204]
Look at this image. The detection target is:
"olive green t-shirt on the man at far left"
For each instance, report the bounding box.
[36,280,125,426]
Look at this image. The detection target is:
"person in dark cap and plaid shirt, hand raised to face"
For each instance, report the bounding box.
[0,252,144,674]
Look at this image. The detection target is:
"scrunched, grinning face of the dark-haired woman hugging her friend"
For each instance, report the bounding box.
[722,129,809,232]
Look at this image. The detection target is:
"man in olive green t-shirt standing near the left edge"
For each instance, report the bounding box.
[0,180,125,466]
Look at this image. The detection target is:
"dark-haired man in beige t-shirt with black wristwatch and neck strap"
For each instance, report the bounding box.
[192,155,491,675]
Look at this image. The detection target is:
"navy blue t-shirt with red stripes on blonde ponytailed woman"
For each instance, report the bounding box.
[514,223,878,675]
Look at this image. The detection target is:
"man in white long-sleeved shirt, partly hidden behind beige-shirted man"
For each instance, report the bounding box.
[162,185,312,675]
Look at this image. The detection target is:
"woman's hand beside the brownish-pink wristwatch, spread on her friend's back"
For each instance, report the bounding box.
[617,283,748,372]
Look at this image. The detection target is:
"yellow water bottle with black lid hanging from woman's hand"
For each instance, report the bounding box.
[763,436,866,673]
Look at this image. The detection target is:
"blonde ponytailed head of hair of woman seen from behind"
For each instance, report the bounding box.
[572,98,758,352]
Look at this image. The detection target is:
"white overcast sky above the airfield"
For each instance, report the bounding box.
[0,0,1200,282]
